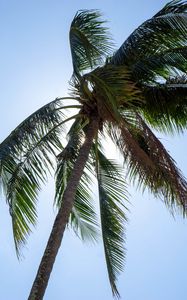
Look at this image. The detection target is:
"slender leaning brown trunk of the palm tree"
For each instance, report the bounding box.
[28,118,98,300]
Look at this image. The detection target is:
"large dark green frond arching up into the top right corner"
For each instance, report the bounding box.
[111,1,187,80]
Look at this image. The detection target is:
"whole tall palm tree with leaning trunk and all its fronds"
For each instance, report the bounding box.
[0,0,187,300]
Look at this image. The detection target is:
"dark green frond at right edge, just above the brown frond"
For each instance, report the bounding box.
[142,77,187,133]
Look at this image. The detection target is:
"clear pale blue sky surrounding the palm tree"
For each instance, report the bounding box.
[0,0,187,300]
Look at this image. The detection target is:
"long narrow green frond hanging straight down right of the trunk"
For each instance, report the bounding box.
[93,147,127,297]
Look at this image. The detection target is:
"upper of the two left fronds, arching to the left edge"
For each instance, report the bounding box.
[0,98,76,175]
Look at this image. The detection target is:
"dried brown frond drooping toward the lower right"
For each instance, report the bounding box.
[109,114,187,214]
